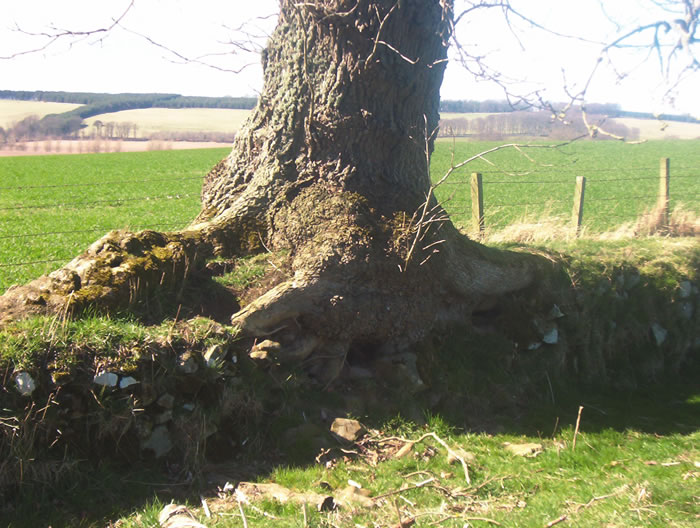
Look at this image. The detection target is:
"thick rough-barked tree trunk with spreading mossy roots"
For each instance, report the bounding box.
[0,0,534,380]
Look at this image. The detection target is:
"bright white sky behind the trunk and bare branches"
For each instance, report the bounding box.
[0,0,700,117]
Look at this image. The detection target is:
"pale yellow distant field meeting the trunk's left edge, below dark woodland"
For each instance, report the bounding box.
[85,108,250,137]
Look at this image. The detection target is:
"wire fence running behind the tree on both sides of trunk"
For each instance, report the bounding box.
[0,160,700,293]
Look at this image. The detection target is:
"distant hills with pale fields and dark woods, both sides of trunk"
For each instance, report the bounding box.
[0,90,700,142]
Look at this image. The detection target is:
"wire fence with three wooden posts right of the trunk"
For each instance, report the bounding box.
[436,158,700,234]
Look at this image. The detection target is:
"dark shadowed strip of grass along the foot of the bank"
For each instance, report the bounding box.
[0,369,700,528]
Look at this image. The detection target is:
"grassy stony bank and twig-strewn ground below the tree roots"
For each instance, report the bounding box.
[0,238,700,528]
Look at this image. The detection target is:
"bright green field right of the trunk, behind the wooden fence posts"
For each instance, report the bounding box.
[432,140,700,232]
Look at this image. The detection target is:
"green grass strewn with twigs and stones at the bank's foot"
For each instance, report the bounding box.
[9,387,700,528]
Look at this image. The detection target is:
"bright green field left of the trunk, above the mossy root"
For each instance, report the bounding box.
[0,149,228,291]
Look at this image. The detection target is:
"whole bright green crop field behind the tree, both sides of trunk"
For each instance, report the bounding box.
[0,140,700,291]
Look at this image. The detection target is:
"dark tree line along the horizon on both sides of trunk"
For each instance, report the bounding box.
[0,90,700,143]
